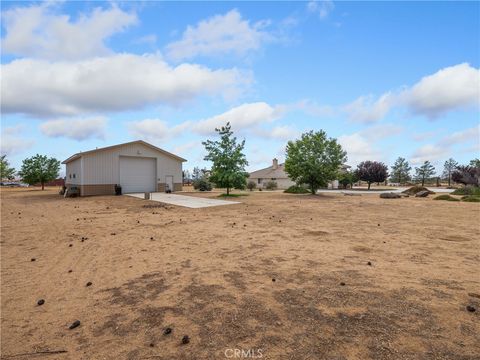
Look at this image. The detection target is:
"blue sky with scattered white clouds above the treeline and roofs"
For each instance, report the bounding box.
[1,1,480,174]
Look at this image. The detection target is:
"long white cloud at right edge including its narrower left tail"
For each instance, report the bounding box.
[344,63,480,123]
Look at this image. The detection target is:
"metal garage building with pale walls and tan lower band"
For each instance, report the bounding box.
[63,140,186,196]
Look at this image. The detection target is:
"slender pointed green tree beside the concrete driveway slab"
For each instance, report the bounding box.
[202,122,248,195]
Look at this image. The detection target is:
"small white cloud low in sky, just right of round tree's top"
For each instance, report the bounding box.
[337,133,383,167]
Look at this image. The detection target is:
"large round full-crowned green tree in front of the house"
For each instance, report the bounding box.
[285,130,347,194]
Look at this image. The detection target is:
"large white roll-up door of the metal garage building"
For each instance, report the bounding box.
[120,156,157,194]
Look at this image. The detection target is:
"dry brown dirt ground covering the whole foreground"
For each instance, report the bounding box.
[1,189,480,360]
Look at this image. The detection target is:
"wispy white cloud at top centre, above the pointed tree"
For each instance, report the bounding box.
[166,9,273,61]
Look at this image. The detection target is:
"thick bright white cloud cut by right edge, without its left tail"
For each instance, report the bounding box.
[401,63,480,118]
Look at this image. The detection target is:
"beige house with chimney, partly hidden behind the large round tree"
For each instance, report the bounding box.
[248,159,350,189]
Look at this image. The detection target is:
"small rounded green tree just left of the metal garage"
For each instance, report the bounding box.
[18,154,60,190]
